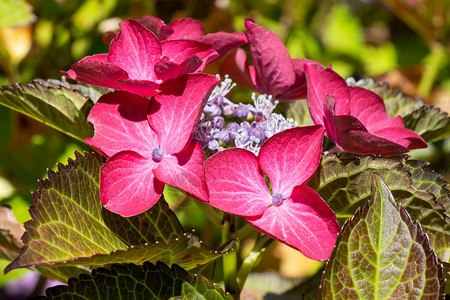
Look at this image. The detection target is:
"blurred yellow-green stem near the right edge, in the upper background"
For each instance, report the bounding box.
[418,42,446,97]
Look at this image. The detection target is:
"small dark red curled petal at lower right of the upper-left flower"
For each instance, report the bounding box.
[155,55,203,81]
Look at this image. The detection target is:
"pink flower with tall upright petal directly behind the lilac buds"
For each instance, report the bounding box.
[222,19,311,101]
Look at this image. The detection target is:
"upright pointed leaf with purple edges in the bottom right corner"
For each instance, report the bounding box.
[321,175,445,299]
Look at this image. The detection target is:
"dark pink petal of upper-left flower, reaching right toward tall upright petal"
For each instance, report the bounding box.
[197,31,247,64]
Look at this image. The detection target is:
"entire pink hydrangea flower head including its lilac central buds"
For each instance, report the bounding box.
[63,16,426,260]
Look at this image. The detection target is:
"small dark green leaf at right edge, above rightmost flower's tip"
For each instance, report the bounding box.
[403,105,450,143]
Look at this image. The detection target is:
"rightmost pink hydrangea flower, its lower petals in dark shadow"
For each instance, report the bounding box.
[305,64,427,155]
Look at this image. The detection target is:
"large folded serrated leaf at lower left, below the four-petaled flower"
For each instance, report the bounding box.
[6,152,235,272]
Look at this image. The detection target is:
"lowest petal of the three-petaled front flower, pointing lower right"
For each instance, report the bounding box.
[247,186,340,260]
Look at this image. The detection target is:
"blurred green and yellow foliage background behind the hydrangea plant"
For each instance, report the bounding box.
[0,0,450,296]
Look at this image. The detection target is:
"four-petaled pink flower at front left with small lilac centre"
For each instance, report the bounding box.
[86,74,218,217]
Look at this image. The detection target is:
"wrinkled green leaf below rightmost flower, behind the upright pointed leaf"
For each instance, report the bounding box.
[309,154,450,235]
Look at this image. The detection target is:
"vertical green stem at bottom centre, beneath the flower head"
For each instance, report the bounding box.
[222,214,240,300]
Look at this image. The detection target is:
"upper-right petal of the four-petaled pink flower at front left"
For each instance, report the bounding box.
[148,74,219,154]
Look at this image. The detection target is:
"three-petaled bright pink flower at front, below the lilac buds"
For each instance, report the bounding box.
[205,125,340,260]
